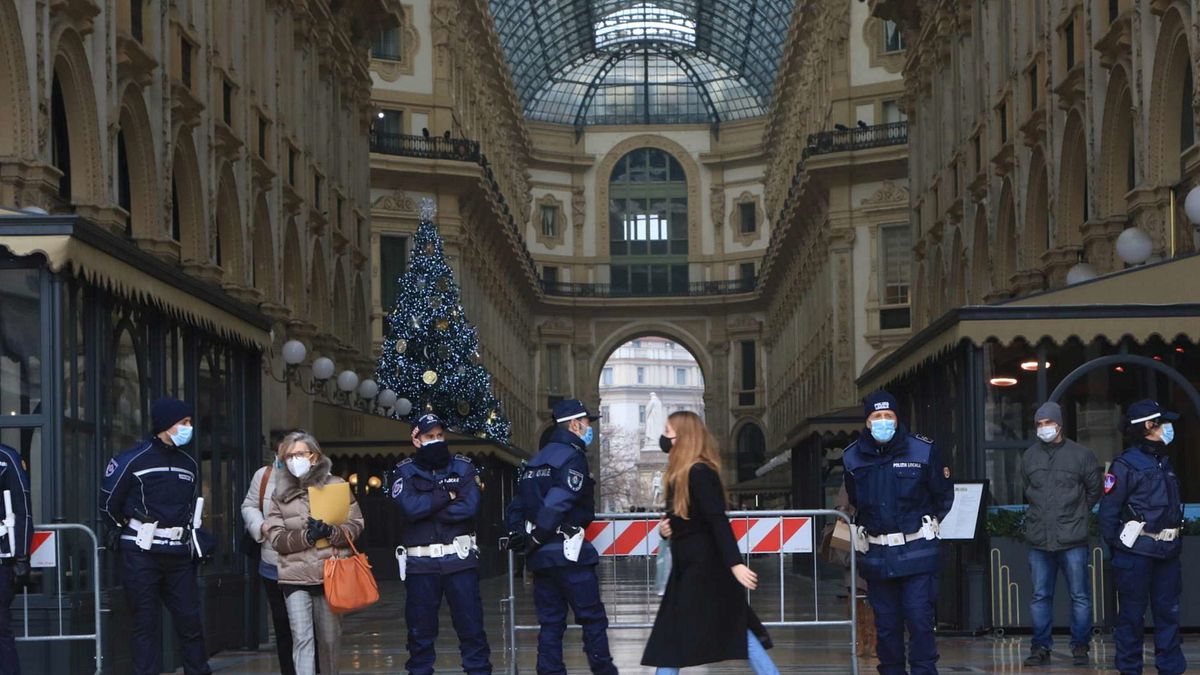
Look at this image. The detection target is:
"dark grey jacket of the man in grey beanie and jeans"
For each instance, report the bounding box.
[1021,438,1104,551]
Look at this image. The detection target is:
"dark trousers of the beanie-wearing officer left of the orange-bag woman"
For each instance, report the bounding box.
[121,549,212,675]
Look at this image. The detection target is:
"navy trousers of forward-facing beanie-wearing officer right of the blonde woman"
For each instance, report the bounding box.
[866,566,937,675]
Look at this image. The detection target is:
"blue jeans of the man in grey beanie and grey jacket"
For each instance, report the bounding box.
[1030,546,1092,649]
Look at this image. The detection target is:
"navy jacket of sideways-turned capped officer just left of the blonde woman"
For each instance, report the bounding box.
[506,429,600,571]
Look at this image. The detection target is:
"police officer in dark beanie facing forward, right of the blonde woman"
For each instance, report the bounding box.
[842,392,954,675]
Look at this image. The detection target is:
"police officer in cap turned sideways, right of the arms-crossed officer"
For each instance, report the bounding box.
[506,399,617,675]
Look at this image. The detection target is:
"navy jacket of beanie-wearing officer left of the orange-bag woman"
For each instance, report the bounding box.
[100,437,199,555]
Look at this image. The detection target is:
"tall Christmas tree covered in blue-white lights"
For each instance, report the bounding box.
[377,198,511,443]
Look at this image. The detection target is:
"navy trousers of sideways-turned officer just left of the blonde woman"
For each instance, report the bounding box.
[533,565,617,675]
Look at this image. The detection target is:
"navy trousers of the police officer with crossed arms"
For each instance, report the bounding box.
[404,568,492,675]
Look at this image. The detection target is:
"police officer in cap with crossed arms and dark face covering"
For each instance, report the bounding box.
[391,413,492,675]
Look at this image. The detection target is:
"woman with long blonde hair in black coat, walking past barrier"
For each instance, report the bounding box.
[642,411,779,675]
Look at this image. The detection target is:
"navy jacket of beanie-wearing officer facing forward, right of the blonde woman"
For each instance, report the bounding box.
[842,425,954,580]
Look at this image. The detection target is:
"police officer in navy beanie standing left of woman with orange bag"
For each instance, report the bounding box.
[100,399,212,675]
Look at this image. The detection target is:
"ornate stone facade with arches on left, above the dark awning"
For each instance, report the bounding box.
[0,0,400,428]
